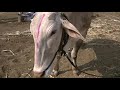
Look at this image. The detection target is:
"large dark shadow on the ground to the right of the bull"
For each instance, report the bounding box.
[79,39,120,78]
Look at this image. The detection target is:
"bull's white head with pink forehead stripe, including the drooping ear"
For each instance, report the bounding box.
[30,12,85,76]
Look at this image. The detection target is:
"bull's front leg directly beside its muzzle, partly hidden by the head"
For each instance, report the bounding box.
[52,52,61,77]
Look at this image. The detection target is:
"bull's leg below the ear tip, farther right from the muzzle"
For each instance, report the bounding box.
[71,40,83,75]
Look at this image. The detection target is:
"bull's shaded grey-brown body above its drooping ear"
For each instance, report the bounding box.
[64,12,93,32]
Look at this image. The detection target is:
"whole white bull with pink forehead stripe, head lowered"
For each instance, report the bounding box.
[30,12,93,77]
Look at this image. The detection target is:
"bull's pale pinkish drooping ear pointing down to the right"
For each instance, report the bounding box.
[61,19,86,42]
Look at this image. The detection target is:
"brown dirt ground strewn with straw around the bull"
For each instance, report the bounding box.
[0,12,120,78]
